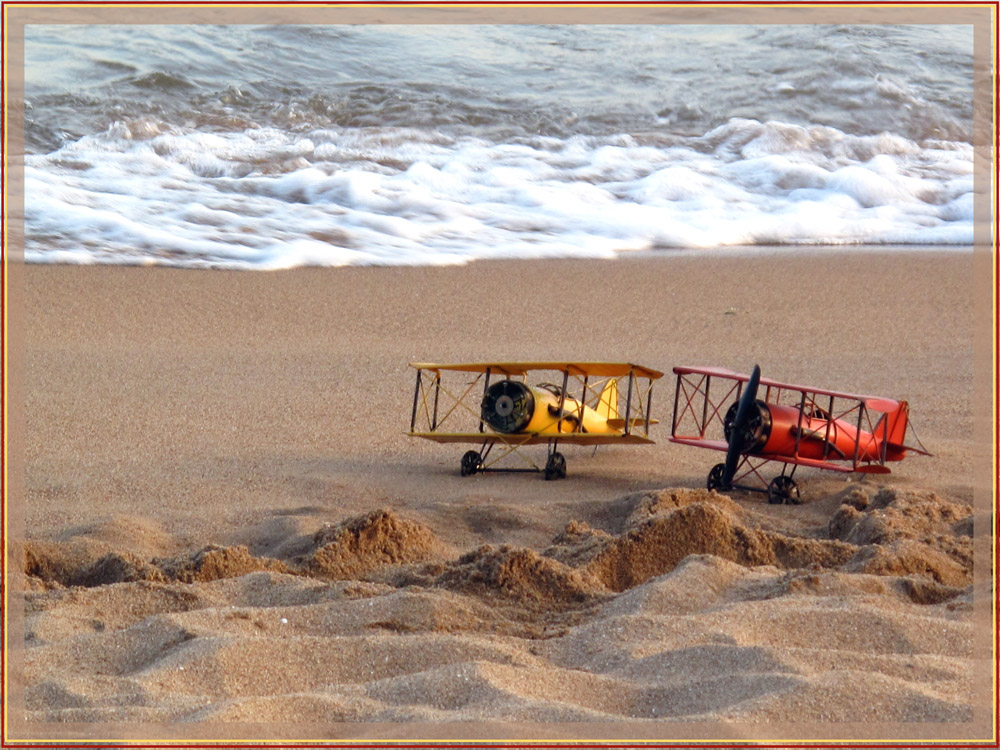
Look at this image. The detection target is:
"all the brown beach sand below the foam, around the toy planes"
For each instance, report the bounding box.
[8,250,992,739]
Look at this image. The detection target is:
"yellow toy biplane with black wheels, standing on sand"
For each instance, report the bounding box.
[407,362,663,479]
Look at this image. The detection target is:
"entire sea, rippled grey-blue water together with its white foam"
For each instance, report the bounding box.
[25,25,973,269]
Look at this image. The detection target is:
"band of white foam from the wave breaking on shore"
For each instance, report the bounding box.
[25,120,973,269]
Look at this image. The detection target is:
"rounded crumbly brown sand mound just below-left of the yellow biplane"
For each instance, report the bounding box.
[301,508,447,579]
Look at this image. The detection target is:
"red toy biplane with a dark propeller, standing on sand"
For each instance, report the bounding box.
[670,366,930,504]
